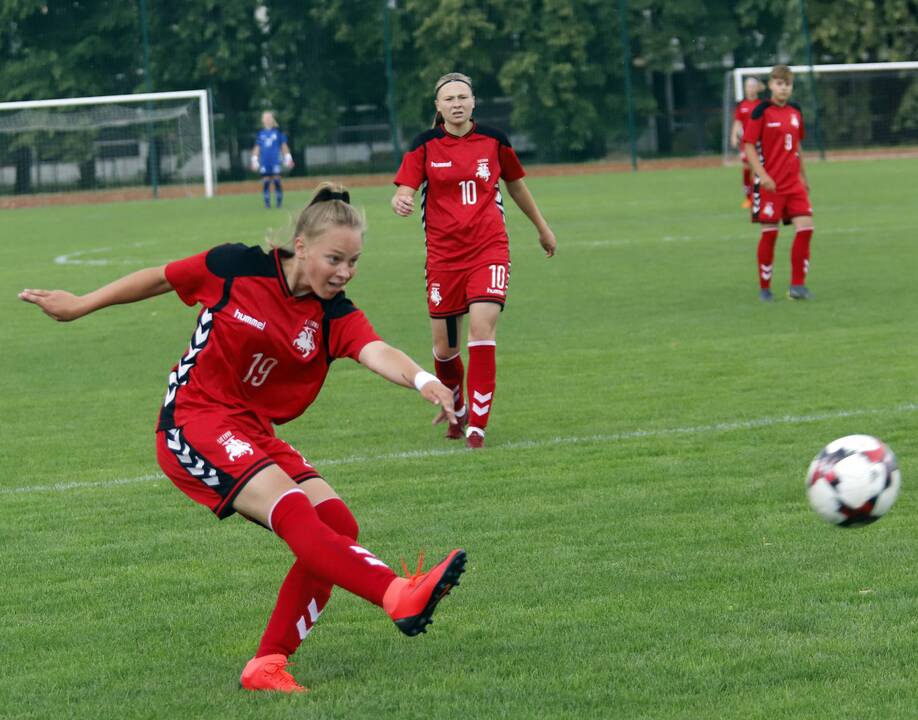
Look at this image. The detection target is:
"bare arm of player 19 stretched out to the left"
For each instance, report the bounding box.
[19,265,172,322]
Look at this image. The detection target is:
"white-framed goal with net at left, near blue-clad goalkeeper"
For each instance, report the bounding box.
[0,90,214,197]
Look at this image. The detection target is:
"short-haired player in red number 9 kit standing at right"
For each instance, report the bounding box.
[743,65,813,301]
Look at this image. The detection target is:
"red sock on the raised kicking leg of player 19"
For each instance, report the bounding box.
[268,489,396,607]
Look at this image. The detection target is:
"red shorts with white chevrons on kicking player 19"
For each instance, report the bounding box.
[156,415,321,520]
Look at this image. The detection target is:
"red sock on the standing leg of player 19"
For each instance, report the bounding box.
[255,498,359,657]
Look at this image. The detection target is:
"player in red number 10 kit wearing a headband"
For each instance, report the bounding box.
[392,73,557,448]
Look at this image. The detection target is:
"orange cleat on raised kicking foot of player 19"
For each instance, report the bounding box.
[383,550,466,637]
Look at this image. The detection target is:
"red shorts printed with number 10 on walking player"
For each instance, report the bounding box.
[427,262,510,318]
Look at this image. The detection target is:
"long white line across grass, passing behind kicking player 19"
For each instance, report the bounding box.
[0,403,918,495]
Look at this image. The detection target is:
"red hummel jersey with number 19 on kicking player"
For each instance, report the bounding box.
[158,244,379,430]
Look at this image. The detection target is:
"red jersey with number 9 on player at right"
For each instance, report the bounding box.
[743,100,805,194]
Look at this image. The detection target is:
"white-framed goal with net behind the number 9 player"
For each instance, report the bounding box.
[723,62,918,162]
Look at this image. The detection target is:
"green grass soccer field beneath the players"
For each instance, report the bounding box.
[0,160,918,720]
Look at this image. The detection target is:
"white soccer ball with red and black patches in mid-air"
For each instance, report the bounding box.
[806,435,902,527]
